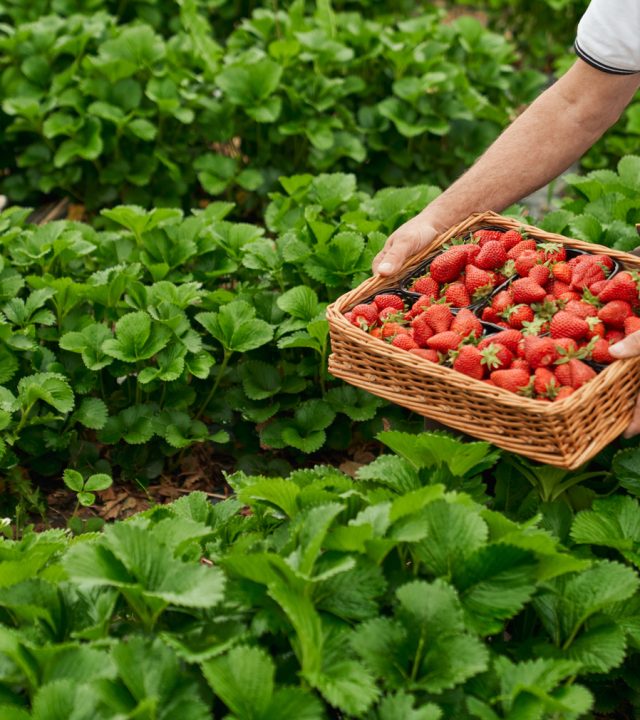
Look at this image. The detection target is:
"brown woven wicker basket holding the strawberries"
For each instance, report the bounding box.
[327,212,640,469]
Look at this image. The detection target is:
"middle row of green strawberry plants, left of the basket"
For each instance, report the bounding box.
[0,174,438,504]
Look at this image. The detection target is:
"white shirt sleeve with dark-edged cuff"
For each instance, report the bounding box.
[575,0,640,75]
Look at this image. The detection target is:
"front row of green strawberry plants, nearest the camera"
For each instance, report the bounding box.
[0,432,640,720]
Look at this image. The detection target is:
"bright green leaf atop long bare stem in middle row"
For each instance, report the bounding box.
[196,300,273,352]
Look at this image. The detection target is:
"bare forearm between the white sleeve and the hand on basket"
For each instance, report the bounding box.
[421,61,638,230]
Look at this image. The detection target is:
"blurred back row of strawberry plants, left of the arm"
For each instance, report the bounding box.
[0,0,542,212]
